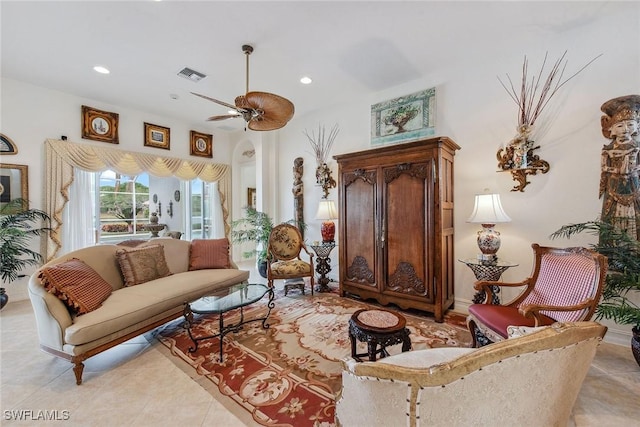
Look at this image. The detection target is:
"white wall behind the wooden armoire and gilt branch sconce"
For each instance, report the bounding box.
[262,3,640,344]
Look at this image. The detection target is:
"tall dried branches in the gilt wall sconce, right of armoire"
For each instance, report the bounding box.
[498,51,602,127]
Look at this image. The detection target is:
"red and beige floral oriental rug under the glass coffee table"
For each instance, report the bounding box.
[153,290,471,427]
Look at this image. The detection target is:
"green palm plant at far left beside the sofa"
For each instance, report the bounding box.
[0,199,50,309]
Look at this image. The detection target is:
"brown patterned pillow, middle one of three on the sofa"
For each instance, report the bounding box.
[116,245,171,286]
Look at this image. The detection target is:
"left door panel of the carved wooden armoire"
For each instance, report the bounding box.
[342,170,377,288]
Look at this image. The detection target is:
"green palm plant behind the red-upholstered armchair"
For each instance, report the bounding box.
[551,218,640,365]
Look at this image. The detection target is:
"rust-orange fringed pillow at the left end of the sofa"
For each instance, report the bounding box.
[38,258,113,314]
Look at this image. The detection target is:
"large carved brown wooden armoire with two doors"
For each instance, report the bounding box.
[333,137,460,322]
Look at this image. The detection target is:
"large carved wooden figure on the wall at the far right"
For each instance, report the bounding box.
[599,95,640,240]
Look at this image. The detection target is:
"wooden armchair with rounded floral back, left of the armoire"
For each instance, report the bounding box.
[267,224,314,295]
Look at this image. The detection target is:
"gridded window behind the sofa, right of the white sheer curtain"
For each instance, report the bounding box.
[96,171,150,243]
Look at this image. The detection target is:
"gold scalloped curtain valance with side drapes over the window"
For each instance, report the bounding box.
[43,139,231,260]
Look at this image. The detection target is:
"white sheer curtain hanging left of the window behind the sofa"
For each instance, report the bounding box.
[61,168,96,254]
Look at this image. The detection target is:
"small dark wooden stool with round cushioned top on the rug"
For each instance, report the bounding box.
[349,309,411,362]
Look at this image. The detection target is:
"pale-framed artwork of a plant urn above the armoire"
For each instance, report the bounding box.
[371,87,436,145]
